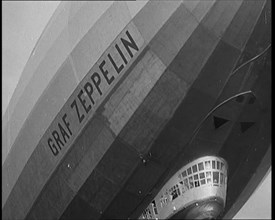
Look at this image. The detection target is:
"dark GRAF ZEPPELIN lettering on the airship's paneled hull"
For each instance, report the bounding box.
[47,30,139,156]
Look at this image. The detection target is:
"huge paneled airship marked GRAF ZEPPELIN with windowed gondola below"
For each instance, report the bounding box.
[2,0,271,220]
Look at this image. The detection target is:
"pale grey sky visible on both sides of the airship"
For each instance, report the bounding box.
[2,1,271,219]
